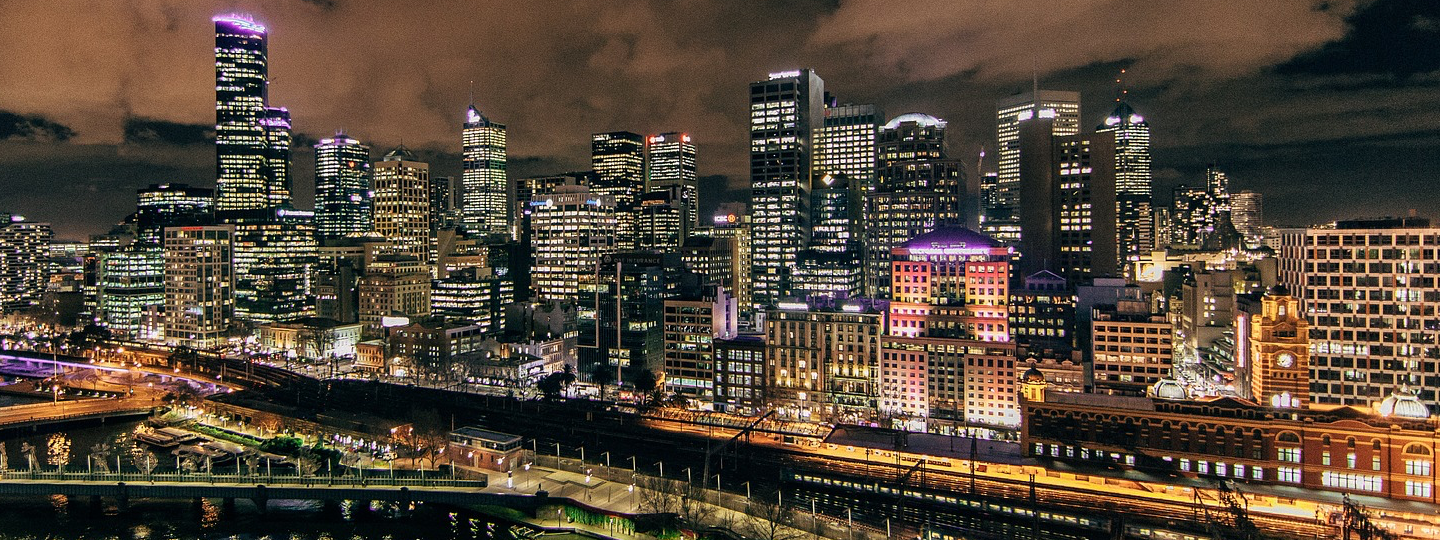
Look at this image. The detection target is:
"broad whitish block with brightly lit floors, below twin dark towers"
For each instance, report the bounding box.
[530,186,615,310]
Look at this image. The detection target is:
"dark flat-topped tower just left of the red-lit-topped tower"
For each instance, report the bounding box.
[590,131,645,251]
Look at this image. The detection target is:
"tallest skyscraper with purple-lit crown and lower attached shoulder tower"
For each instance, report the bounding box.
[213,14,291,210]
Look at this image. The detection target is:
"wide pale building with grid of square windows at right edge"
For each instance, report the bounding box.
[1279,217,1440,406]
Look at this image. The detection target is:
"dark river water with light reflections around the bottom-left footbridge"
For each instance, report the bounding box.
[0,422,541,540]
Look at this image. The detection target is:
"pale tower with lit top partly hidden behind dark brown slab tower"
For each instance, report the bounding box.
[984,89,1080,242]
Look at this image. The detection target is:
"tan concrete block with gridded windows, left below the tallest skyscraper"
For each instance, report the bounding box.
[164,225,235,348]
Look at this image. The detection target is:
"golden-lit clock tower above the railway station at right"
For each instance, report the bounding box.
[1248,285,1310,409]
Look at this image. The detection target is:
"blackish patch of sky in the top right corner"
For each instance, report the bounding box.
[1276,0,1440,79]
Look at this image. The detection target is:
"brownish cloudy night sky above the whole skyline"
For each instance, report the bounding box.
[0,0,1440,239]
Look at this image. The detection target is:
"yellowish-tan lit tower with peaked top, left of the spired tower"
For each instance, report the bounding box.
[374,145,429,264]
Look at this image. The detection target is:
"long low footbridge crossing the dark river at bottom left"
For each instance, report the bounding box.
[0,471,529,513]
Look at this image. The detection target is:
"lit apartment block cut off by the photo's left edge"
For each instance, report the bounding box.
[0,213,53,311]
